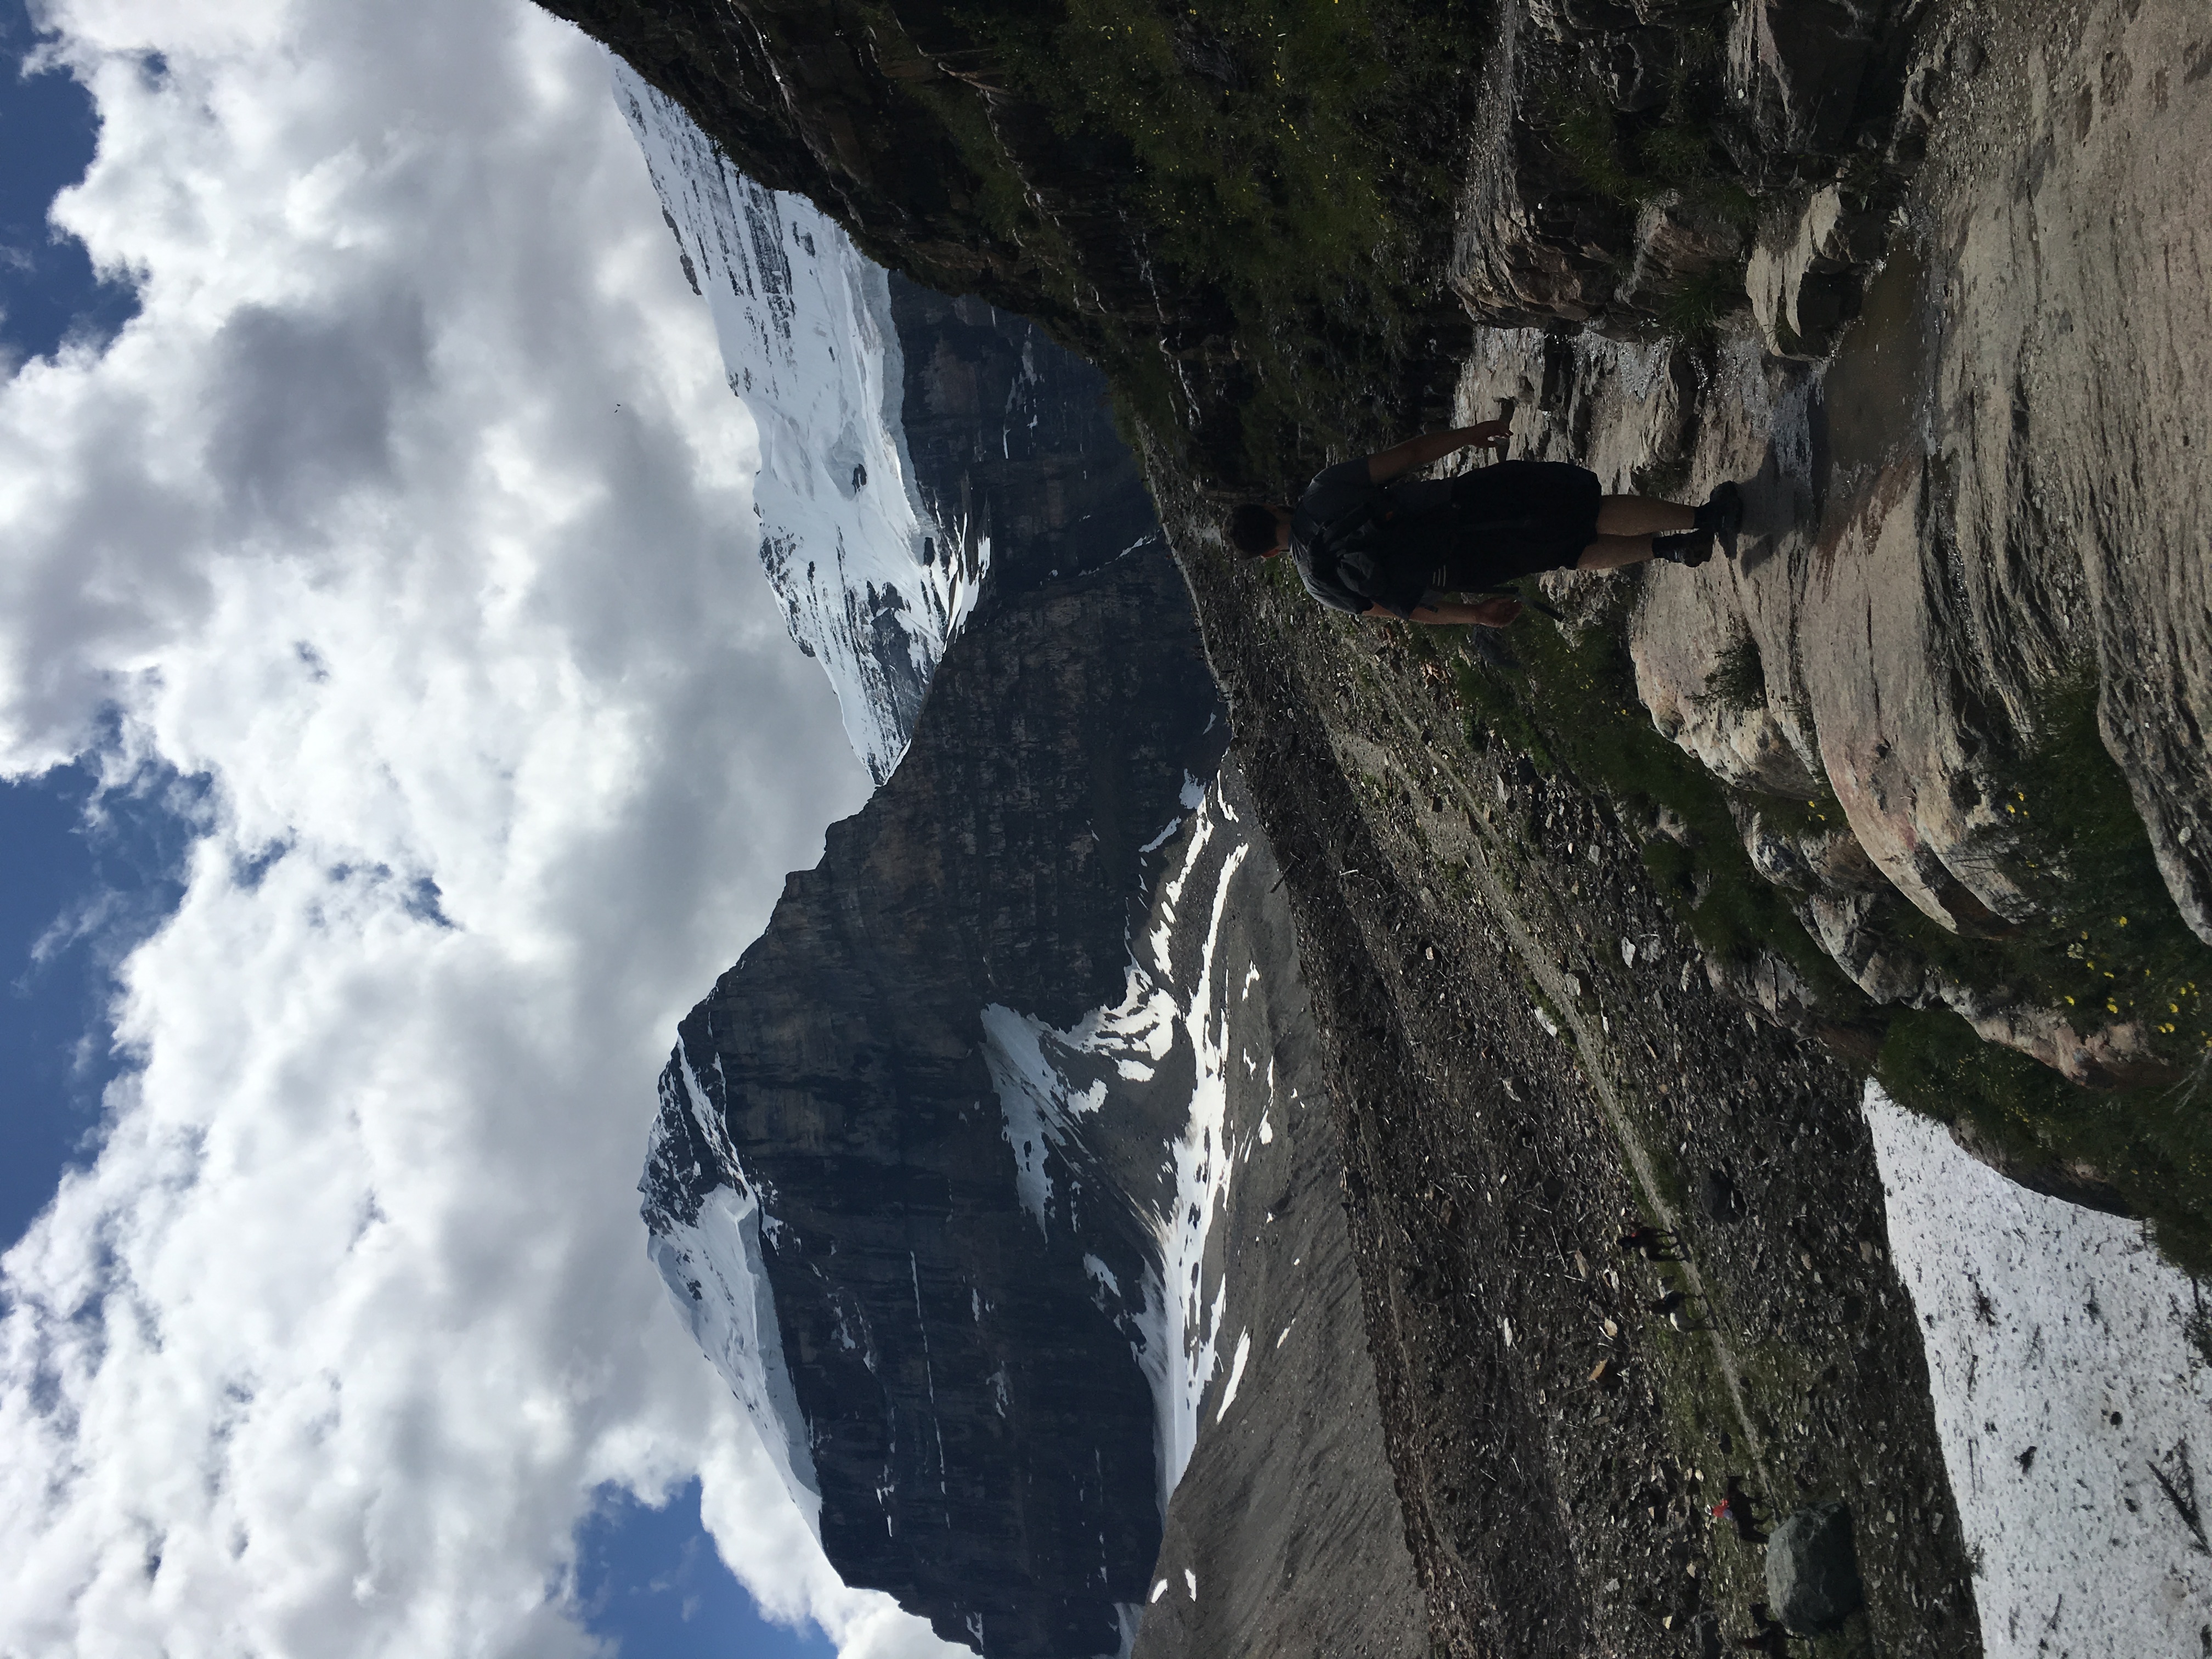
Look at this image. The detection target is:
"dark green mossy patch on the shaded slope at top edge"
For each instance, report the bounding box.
[953,0,1480,480]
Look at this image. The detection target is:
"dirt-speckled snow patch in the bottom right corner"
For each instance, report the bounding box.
[1865,1084,2212,1659]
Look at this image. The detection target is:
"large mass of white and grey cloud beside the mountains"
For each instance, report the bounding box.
[0,0,960,1659]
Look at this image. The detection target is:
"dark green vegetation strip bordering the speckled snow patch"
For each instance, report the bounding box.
[1876,1009,2212,1276]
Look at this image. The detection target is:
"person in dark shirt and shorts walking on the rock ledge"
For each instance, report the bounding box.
[1223,420,1743,628]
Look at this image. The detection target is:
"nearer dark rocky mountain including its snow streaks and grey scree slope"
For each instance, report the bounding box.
[644,540,1418,1659]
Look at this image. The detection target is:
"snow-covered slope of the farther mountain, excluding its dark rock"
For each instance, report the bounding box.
[611,58,989,783]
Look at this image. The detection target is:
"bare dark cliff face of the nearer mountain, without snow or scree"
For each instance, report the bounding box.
[648,546,1226,1655]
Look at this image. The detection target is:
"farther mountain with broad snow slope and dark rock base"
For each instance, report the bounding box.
[613,62,1159,783]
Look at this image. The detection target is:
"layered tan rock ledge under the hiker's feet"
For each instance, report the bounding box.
[1462,0,2212,1086]
